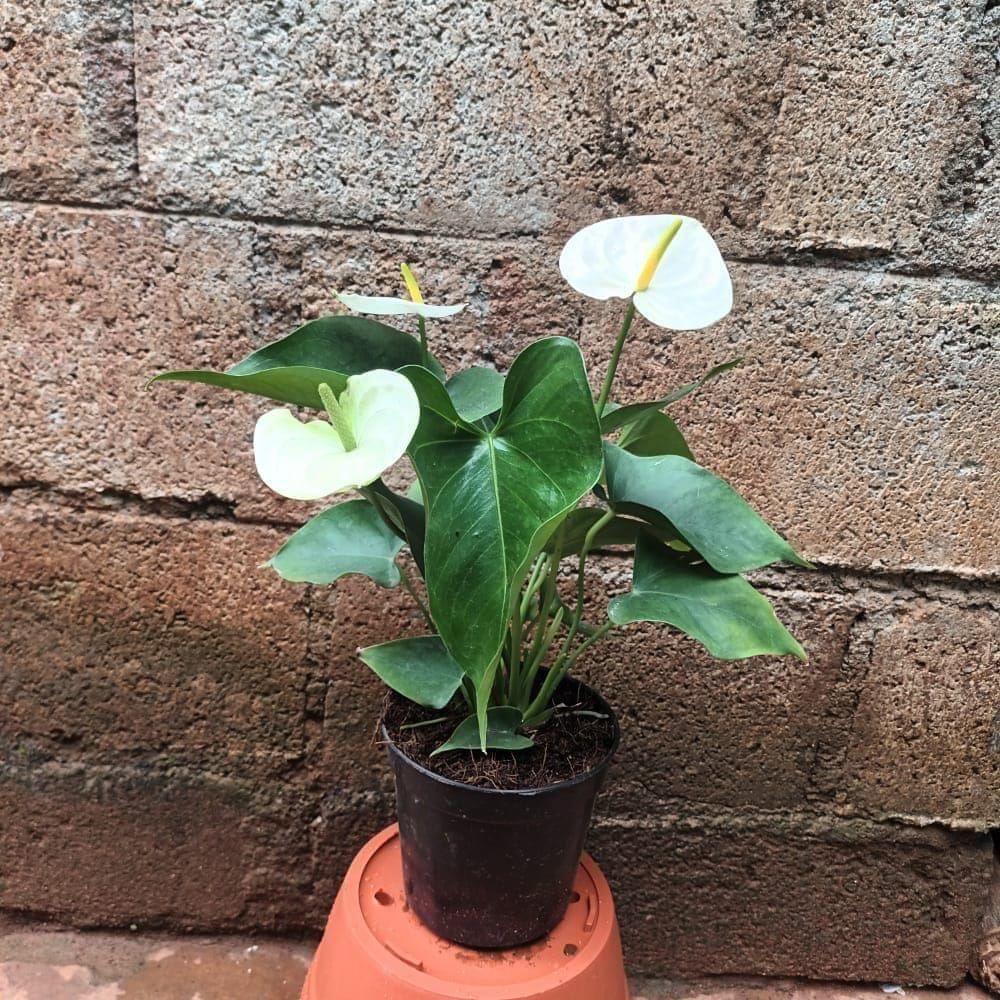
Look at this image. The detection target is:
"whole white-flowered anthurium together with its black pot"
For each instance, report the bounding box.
[154,215,808,947]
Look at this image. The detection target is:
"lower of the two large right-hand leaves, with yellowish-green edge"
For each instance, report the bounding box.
[608,533,806,660]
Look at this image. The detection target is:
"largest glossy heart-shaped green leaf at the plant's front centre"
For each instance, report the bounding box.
[404,337,601,740]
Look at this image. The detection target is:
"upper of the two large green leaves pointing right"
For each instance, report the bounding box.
[604,442,810,573]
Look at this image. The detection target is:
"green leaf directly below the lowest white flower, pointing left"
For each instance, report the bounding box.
[268,500,403,587]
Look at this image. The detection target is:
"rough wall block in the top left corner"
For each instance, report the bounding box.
[0,0,137,203]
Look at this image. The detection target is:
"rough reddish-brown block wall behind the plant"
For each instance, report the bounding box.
[0,0,1000,983]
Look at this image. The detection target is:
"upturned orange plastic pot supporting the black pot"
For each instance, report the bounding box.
[302,826,629,1000]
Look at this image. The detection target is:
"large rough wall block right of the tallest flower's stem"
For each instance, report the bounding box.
[628,267,1000,578]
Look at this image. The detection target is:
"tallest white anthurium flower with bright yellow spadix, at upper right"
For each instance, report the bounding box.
[559,215,733,330]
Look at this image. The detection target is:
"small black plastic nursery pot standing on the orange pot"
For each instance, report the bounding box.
[382,684,619,948]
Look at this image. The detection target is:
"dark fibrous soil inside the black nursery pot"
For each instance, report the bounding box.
[380,679,617,790]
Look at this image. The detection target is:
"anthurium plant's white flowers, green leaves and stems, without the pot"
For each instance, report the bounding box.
[154,215,807,752]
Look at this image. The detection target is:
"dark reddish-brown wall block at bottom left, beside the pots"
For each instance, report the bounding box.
[0,745,392,936]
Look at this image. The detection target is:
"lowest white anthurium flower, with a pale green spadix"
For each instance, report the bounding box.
[253,368,420,500]
